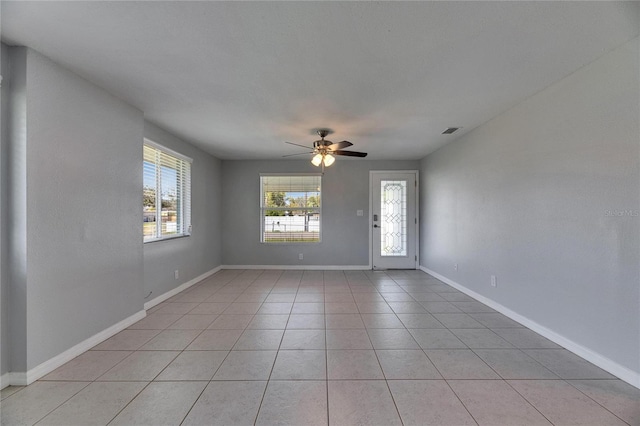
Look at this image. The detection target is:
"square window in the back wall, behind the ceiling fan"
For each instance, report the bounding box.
[260,175,321,243]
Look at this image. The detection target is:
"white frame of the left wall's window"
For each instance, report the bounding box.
[142,138,193,244]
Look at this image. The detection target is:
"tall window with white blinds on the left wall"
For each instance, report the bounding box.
[142,140,193,242]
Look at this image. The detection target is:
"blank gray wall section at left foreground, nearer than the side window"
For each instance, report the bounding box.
[9,48,143,371]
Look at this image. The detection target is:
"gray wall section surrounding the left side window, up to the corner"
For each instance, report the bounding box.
[144,123,222,301]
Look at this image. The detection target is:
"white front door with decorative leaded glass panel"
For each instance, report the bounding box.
[369,170,418,269]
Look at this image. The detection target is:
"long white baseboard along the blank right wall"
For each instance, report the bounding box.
[420,266,640,388]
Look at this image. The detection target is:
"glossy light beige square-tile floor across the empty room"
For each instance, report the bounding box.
[0,270,640,426]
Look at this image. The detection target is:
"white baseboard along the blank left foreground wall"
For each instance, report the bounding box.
[1,311,147,388]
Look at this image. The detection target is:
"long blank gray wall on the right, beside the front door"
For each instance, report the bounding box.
[421,39,640,372]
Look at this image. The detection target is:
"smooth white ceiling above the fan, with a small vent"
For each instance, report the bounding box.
[0,1,640,159]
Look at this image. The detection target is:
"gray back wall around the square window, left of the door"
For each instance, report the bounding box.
[222,158,419,267]
